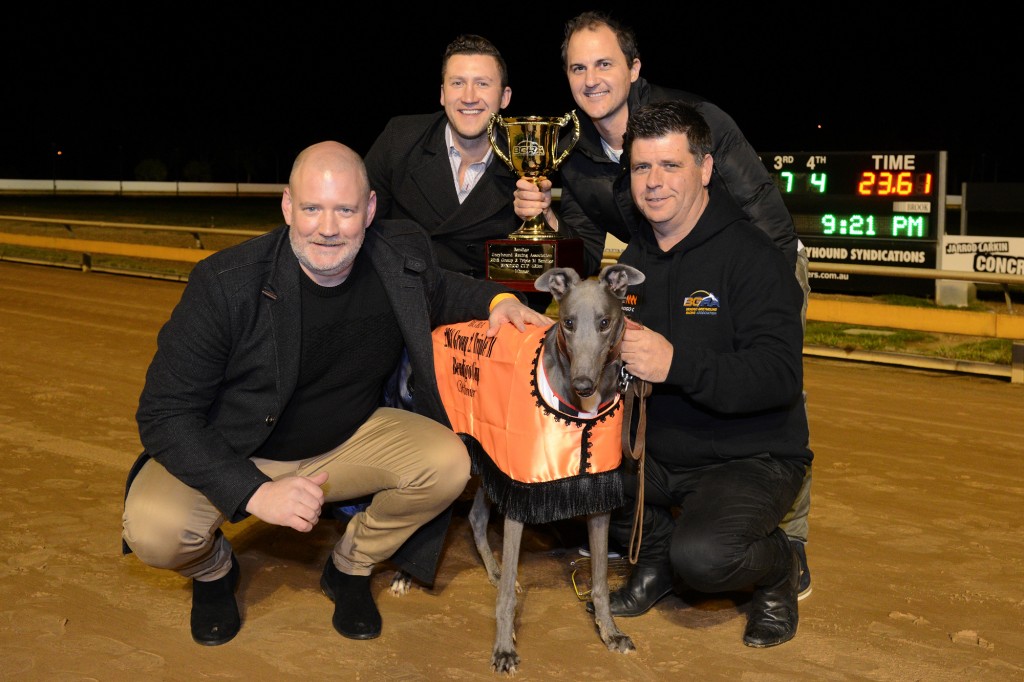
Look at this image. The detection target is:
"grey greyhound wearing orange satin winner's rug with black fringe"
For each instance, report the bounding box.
[421,264,644,674]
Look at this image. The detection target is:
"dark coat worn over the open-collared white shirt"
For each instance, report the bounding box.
[366,112,522,279]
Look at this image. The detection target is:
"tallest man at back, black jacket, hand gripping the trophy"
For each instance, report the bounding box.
[514,11,811,599]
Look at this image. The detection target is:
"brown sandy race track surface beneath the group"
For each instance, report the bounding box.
[0,262,1024,682]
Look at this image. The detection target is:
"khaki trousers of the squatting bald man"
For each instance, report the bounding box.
[122,408,470,582]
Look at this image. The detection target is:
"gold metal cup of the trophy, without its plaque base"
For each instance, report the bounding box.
[487,110,580,240]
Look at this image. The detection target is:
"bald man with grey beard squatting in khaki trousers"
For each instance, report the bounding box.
[123,142,550,645]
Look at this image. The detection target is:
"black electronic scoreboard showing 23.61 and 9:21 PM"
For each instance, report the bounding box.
[760,152,946,295]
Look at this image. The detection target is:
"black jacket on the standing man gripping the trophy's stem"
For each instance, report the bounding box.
[558,78,797,274]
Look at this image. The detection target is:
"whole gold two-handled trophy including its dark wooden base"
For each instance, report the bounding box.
[486,111,584,291]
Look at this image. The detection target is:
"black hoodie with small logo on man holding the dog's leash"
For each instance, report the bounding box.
[618,181,813,467]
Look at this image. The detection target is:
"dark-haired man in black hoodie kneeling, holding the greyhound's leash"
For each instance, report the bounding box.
[598,101,813,647]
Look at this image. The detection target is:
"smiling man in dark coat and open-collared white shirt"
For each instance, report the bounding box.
[366,35,551,311]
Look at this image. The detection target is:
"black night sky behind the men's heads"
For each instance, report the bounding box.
[0,0,1024,194]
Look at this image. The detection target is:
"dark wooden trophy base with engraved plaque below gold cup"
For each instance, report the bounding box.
[486,237,584,291]
